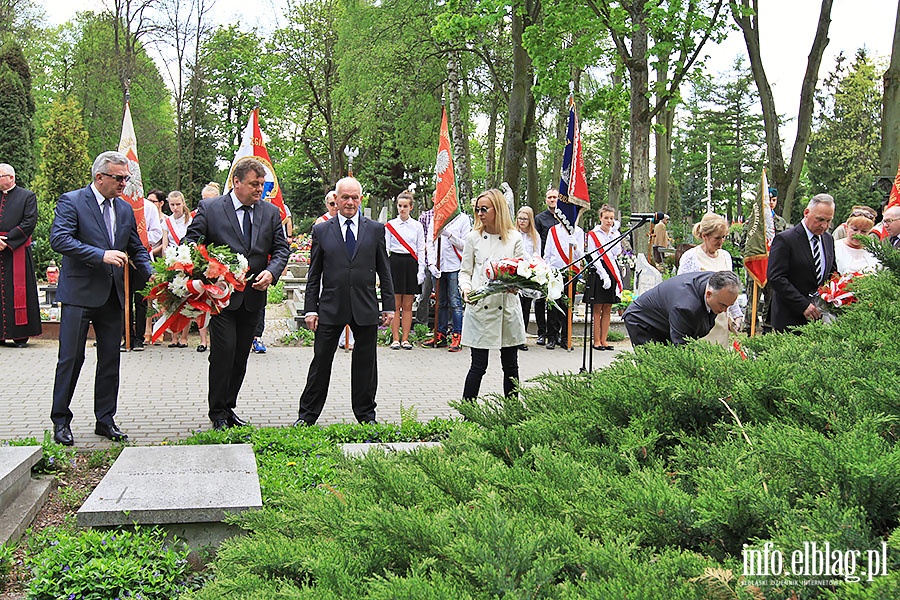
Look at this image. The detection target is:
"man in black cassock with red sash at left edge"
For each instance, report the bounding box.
[0,163,41,348]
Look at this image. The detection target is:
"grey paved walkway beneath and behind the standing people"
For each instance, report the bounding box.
[0,327,631,448]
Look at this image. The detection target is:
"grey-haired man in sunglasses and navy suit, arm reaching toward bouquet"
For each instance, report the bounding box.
[50,152,152,446]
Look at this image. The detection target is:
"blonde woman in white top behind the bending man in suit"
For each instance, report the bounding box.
[678,213,744,347]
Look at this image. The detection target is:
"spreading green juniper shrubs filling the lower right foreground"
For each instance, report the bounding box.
[179,241,900,600]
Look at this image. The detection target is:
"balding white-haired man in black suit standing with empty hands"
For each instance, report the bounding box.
[294,177,394,425]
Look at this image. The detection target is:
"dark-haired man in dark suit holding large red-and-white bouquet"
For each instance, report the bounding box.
[184,156,290,429]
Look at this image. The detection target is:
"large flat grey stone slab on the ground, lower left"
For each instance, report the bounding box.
[77,444,262,527]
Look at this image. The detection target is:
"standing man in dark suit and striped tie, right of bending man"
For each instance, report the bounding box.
[766,194,835,331]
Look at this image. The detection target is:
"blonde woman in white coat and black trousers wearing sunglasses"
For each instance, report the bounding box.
[459,189,525,400]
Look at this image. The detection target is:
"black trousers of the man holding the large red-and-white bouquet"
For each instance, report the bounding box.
[209,305,259,421]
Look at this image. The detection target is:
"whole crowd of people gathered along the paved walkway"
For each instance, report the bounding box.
[0,152,900,445]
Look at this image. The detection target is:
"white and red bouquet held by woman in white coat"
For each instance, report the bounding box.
[468,258,565,308]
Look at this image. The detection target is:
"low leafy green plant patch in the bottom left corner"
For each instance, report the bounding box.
[26,527,187,600]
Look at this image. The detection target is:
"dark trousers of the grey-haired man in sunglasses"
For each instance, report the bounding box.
[50,286,123,425]
